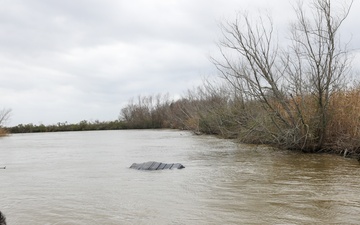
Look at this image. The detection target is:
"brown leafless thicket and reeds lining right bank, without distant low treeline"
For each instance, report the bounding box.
[120,82,360,155]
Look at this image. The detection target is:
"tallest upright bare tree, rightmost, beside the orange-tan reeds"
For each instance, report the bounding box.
[288,0,353,149]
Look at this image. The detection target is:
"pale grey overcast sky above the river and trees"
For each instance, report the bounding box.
[0,0,360,126]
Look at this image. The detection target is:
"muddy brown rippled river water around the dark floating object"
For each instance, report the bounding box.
[0,130,360,225]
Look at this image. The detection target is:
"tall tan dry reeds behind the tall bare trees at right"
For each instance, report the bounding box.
[260,86,360,155]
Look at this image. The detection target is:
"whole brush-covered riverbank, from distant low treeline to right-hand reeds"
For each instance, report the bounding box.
[7,86,360,162]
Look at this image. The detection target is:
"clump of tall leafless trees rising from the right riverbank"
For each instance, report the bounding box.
[213,0,352,150]
